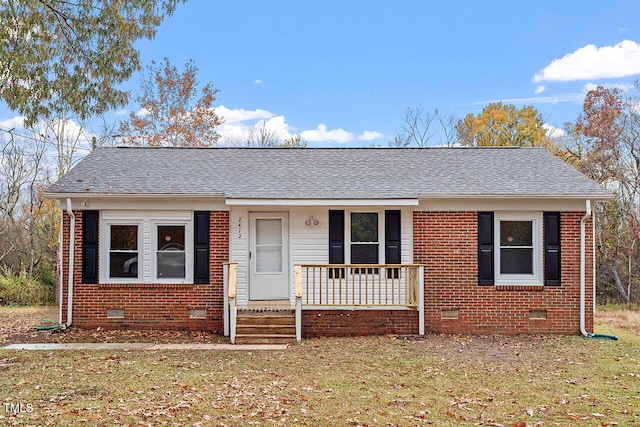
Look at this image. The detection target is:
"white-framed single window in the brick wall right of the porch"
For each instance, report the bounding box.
[495,212,542,285]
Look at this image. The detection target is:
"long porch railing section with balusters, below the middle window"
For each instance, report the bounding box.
[296,264,424,308]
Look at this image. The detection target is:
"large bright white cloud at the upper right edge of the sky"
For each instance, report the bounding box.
[533,40,640,82]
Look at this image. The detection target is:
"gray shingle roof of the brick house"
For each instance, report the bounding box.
[42,147,611,199]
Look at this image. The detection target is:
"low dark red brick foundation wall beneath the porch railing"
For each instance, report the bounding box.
[302,310,418,338]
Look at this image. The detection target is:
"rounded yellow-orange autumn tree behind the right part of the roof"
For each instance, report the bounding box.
[456,102,550,147]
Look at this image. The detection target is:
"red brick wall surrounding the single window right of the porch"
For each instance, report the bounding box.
[413,212,593,334]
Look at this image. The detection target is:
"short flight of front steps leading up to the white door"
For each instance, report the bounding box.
[236,310,296,344]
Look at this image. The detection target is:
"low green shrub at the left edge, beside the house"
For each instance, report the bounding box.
[0,269,47,306]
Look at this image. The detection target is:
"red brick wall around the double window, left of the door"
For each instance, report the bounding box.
[62,211,229,333]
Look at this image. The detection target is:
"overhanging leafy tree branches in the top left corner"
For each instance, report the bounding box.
[0,0,184,126]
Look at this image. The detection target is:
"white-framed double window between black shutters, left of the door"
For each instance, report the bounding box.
[99,211,194,283]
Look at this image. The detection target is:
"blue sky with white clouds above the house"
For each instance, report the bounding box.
[0,0,640,146]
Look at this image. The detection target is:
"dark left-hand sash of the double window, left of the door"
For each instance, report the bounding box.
[109,225,138,278]
